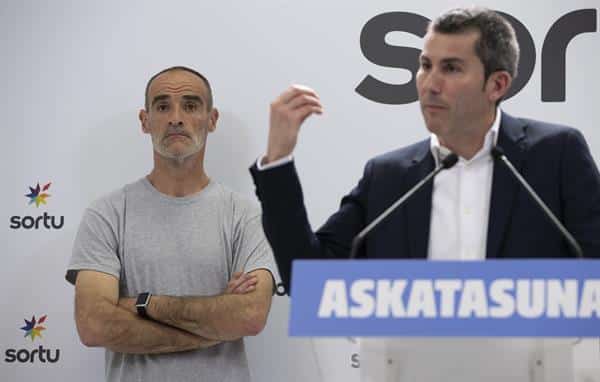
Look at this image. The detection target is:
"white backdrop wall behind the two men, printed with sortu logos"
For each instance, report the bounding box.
[0,0,600,381]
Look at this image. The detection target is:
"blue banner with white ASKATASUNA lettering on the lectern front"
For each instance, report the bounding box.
[289,260,600,337]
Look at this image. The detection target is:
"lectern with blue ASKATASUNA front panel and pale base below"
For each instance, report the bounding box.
[290,260,600,382]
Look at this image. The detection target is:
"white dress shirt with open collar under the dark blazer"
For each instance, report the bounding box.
[256,108,502,260]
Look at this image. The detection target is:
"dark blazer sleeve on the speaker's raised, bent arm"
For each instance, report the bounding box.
[250,162,372,294]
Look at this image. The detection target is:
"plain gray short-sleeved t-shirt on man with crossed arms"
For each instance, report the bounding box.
[66,178,275,382]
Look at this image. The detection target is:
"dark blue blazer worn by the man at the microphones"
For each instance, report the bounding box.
[250,113,600,291]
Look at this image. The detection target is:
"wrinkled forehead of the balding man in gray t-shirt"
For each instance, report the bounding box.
[148,70,208,102]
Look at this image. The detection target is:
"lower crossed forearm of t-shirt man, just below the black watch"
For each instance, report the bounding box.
[78,302,219,354]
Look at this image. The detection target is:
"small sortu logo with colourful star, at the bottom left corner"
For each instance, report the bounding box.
[4,315,60,363]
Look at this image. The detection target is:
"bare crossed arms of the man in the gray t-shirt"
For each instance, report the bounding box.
[75,269,273,354]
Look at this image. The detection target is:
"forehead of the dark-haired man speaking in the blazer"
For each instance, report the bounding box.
[421,29,481,60]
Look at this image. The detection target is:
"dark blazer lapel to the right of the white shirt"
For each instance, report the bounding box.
[486,113,527,258]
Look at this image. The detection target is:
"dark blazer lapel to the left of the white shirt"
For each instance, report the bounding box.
[405,145,435,259]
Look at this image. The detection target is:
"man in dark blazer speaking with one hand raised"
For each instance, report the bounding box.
[250,9,600,290]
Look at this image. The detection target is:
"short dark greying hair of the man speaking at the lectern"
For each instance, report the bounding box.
[429,7,519,80]
